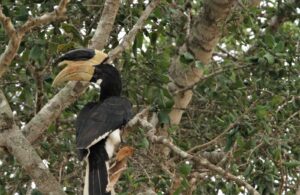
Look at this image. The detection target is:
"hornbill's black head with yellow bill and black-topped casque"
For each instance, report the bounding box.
[52,49,122,100]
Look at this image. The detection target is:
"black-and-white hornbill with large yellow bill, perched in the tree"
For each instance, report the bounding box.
[53,49,132,195]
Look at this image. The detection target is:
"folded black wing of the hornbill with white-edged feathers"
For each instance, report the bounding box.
[75,97,132,149]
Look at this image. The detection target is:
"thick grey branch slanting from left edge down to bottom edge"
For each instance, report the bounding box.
[0,90,65,194]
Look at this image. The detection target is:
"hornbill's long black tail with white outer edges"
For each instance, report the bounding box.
[83,152,111,195]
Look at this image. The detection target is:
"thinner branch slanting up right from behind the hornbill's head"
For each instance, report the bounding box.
[108,0,160,61]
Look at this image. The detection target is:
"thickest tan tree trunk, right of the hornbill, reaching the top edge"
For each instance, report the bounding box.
[169,0,236,125]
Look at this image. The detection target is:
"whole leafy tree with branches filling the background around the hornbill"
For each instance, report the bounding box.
[0,0,300,194]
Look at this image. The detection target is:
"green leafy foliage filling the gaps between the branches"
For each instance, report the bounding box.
[0,0,300,194]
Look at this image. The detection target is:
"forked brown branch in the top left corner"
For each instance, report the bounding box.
[0,0,68,77]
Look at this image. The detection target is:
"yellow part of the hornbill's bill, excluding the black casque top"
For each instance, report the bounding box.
[52,51,107,87]
